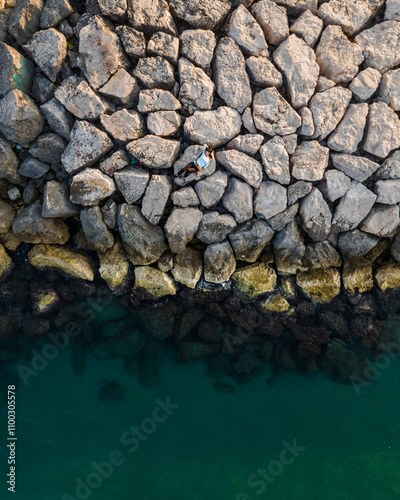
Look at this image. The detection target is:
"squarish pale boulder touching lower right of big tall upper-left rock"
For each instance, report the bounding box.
[99,68,140,109]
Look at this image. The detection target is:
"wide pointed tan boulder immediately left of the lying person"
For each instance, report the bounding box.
[126,135,181,168]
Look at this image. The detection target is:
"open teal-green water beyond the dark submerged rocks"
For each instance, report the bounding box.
[0,322,400,500]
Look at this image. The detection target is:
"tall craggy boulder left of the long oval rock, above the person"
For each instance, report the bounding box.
[178,57,214,115]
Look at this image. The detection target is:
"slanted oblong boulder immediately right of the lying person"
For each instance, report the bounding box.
[215,149,262,188]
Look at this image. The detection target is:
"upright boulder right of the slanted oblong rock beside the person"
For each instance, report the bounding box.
[260,135,290,184]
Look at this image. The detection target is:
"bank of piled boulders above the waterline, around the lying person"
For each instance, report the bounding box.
[0,0,400,310]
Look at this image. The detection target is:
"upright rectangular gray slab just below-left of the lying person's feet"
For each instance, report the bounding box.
[142,175,172,224]
